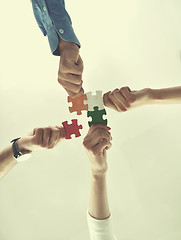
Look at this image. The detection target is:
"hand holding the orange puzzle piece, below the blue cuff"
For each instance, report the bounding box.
[58,39,84,98]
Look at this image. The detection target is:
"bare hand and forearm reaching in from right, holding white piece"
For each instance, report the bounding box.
[103,87,181,112]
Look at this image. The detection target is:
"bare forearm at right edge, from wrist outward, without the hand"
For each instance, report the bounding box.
[151,87,181,104]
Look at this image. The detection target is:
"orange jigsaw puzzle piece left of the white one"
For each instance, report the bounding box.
[68,94,88,115]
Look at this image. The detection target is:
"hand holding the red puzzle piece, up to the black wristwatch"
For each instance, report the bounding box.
[17,126,66,151]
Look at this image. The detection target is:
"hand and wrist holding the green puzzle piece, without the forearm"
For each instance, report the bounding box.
[83,124,112,176]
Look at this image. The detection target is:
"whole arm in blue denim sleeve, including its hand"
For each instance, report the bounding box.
[31,0,84,98]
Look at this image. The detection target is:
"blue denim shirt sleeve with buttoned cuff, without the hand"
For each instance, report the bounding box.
[31,0,80,56]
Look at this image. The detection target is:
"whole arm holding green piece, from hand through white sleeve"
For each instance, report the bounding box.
[83,124,116,240]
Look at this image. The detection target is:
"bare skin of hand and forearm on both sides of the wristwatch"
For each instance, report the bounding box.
[0,126,66,179]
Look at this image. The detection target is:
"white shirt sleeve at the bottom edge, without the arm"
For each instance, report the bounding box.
[87,211,117,240]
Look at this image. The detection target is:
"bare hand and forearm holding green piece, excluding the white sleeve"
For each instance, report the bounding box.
[83,124,112,220]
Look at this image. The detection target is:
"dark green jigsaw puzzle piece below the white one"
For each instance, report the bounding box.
[87,106,107,127]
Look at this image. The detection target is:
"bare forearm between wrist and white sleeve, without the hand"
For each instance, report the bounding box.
[89,174,110,220]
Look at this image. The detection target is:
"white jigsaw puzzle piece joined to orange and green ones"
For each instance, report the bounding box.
[84,91,104,111]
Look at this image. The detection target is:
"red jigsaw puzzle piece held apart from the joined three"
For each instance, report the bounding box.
[62,119,83,139]
